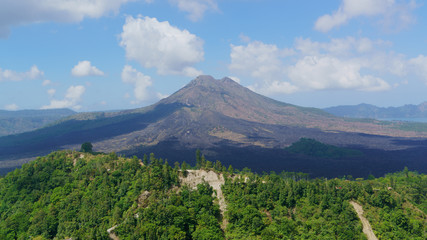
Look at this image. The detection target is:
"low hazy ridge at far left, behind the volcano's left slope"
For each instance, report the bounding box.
[0,109,76,136]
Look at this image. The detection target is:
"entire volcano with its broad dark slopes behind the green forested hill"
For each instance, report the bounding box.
[0,76,427,176]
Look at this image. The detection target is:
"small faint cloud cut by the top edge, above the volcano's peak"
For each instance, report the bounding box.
[169,0,218,21]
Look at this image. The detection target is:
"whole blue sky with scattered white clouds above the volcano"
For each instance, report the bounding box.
[0,0,427,111]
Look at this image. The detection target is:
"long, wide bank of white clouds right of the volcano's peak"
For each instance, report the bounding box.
[229,37,414,95]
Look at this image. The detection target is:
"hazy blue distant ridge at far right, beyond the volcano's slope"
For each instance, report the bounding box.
[323,102,427,119]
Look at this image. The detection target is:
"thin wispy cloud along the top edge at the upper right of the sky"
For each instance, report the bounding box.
[314,0,416,32]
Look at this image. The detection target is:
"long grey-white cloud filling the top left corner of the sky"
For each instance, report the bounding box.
[0,0,133,37]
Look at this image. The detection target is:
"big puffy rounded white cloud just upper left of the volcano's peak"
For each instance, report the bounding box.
[120,16,204,77]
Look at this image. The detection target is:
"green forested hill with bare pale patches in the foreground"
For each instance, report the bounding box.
[0,151,427,239]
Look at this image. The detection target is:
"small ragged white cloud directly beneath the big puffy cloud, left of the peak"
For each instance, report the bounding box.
[122,65,152,104]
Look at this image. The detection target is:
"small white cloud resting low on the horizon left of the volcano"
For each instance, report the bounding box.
[41,85,86,110]
